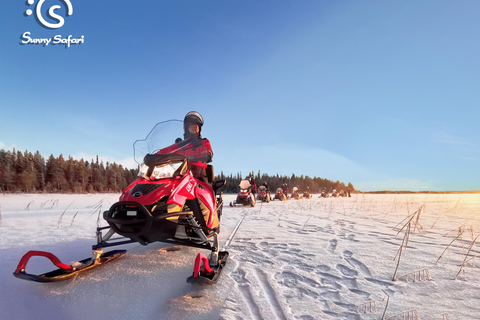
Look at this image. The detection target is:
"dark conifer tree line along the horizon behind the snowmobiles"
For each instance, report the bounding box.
[0,149,354,193]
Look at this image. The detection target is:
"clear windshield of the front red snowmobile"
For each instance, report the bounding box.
[133,120,183,166]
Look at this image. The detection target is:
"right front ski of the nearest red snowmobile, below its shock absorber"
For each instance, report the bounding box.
[187,251,228,284]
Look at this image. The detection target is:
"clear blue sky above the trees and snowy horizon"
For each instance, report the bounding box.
[0,0,480,191]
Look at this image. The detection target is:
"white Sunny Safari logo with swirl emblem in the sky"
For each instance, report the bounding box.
[20,0,85,48]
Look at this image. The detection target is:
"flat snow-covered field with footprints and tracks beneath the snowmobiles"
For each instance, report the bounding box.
[0,194,480,320]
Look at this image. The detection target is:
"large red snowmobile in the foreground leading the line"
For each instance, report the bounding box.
[14,120,228,283]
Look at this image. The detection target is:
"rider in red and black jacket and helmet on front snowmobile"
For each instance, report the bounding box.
[157,111,213,183]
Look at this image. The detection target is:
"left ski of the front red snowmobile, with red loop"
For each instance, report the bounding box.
[13,250,127,282]
